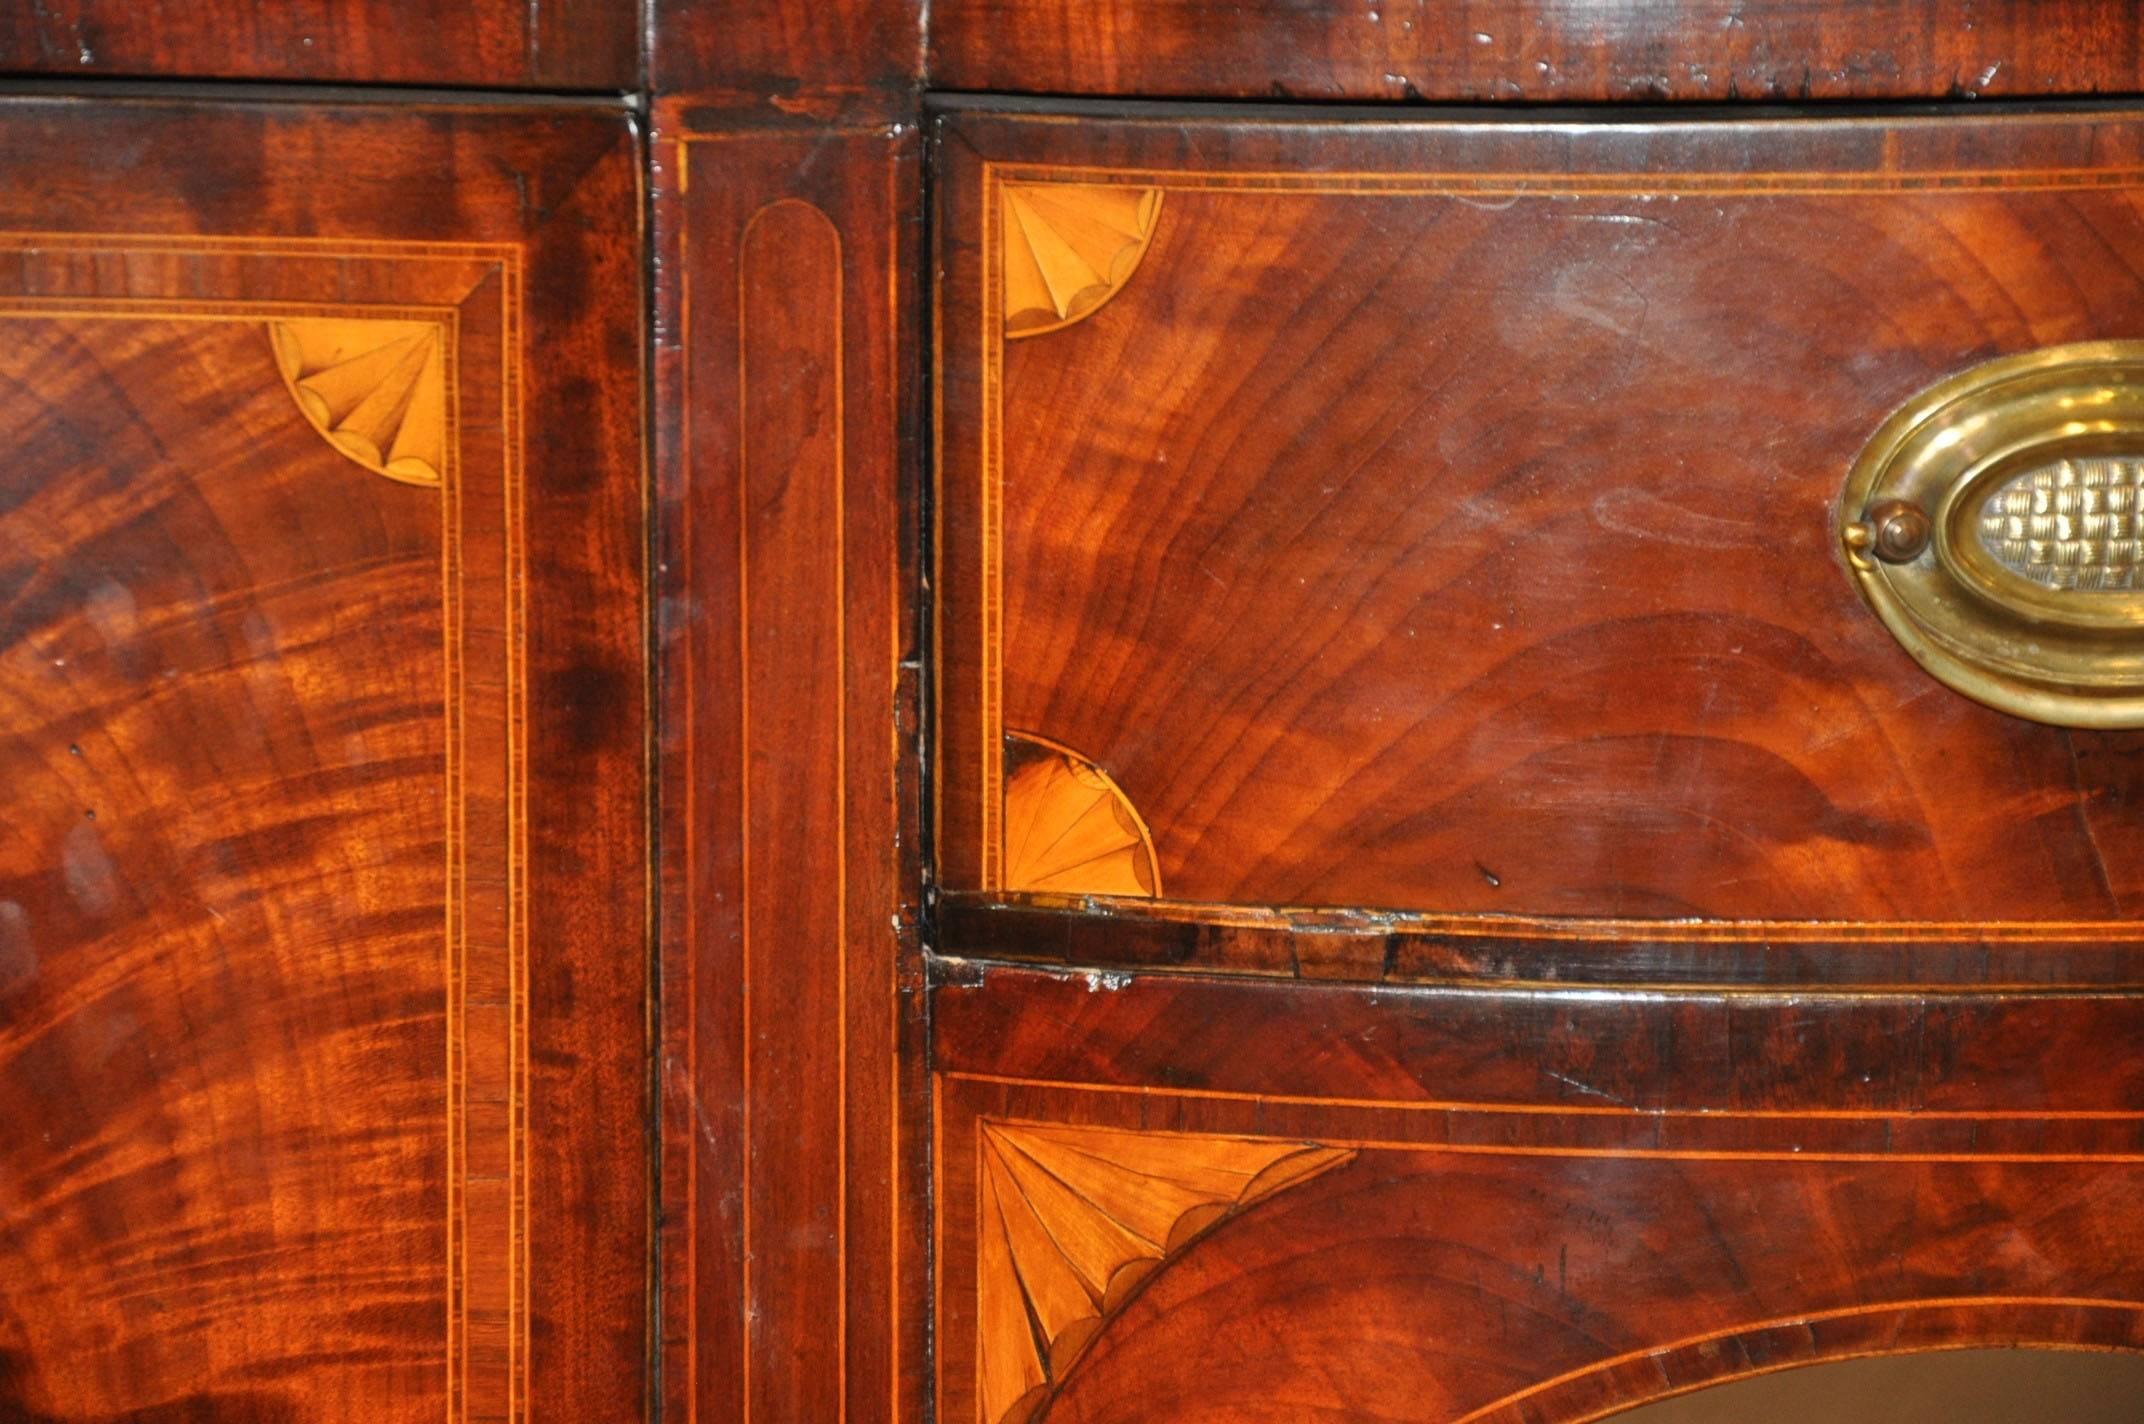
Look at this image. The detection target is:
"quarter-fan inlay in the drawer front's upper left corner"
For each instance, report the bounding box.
[999,182,1162,337]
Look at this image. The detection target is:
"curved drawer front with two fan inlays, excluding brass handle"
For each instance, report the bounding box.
[937,109,2144,939]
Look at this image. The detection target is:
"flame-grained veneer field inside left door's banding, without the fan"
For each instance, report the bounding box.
[0,293,467,1418]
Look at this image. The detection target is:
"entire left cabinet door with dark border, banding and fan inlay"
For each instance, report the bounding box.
[0,101,650,1424]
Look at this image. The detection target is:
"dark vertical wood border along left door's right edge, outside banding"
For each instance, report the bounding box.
[523,102,654,1424]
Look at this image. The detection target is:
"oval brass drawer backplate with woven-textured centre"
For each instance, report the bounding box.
[1837,341,2144,727]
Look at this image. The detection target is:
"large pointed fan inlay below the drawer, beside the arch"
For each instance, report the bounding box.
[976,1119,1355,1424]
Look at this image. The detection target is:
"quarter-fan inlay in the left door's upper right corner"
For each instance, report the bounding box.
[268,317,446,485]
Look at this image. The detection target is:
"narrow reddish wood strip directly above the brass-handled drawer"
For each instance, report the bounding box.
[928,0,2144,103]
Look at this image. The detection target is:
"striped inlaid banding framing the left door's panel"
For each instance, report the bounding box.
[0,232,530,1424]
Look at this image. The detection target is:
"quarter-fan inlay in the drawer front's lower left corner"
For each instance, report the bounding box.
[1003,731,1162,896]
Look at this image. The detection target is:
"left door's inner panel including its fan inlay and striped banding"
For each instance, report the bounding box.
[0,238,525,1409]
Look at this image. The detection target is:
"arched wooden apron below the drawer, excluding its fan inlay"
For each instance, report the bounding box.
[935,971,2144,1424]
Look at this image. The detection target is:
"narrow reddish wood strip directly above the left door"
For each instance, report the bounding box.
[0,0,639,90]
